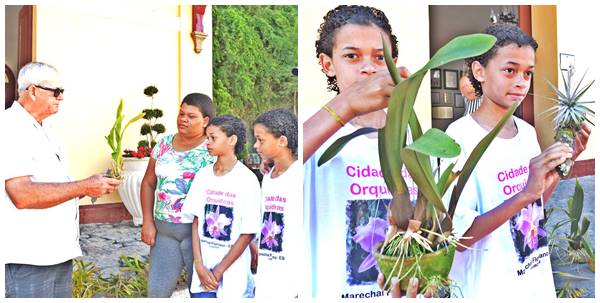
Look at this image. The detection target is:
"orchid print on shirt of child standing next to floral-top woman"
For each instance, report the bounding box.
[202,204,233,241]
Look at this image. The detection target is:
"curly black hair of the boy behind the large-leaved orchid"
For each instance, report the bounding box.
[315,5,398,94]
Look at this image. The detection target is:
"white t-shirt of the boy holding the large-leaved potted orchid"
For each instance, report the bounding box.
[304,124,417,299]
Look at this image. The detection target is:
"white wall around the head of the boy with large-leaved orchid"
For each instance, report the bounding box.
[298,4,431,130]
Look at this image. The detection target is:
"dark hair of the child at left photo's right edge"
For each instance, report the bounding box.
[254,108,298,155]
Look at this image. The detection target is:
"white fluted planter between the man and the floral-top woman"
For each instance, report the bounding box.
[118,158,150,225]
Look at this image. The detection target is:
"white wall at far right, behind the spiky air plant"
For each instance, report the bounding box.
[556,2,600,160]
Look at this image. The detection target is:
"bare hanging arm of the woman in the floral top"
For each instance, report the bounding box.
[140,158,156,246]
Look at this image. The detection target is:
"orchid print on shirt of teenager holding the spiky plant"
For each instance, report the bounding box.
[510,199,548,263]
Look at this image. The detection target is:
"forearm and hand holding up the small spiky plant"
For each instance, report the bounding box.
[456,143,572,251]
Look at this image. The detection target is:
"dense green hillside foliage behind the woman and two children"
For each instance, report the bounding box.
[213,5,298,130]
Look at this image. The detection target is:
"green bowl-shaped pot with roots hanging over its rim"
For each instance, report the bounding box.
[373,242,456,293]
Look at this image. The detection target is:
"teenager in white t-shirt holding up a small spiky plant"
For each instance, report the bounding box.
[443,24,590,298]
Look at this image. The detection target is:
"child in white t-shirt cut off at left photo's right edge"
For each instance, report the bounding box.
[254,109,305,299]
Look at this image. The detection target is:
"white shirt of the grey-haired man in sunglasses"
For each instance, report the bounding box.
[0,102,81,265]
